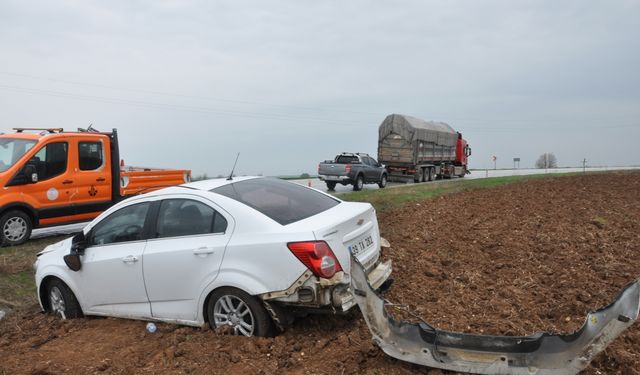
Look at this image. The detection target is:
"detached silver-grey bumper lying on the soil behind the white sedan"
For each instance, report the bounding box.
[351,257,640,375]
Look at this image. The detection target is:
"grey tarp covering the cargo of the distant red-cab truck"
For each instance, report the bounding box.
[378,114,458,147]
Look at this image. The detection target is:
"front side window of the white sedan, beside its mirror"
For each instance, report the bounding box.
[89,203,149,246]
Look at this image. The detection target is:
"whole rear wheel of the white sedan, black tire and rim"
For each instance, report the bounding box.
[207,287,273,337]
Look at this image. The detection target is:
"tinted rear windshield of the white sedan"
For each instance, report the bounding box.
[211,178,340,225]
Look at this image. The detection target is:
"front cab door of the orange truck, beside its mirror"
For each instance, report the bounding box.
[16,142,76,225]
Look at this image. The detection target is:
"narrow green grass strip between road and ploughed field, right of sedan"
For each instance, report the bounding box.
[336,172,583,211]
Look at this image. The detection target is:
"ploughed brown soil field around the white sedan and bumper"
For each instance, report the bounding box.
[0,173,640,375]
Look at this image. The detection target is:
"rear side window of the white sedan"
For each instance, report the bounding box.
[156,199,227,238]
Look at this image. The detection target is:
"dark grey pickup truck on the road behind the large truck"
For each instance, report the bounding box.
[318,152,387,191]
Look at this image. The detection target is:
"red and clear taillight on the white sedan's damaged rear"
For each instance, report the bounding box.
[287,241,342,279]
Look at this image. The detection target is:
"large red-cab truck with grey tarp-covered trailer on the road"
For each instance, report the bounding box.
[378,114,471,182]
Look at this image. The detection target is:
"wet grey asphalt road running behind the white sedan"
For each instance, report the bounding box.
[31,167,640,239]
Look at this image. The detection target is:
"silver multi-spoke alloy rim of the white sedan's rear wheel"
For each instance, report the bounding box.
[213,295,255,336]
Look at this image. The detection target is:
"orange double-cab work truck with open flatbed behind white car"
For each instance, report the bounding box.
[0,128,191,246]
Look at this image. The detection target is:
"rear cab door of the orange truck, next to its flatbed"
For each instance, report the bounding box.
[72,136,112,219]
